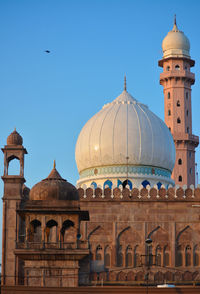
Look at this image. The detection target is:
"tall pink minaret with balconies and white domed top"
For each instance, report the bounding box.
[158,17,199,186]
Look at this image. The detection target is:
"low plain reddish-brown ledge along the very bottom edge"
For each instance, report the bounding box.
[1,286,200,294]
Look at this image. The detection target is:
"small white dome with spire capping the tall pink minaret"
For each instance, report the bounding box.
[162,19,190,58]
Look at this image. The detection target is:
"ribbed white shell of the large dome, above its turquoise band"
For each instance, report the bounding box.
[76,90,175,173]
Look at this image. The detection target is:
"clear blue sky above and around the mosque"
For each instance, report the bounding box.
[0,0,200,258]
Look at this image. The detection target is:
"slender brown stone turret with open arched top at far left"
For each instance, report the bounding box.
[2,130,27,286]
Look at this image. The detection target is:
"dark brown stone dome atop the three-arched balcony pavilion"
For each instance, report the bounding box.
[29,165,79,200]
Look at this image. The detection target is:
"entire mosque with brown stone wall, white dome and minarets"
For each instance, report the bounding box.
[1,20,200,293]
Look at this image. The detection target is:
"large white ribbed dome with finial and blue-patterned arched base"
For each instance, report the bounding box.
[75,80,175,188]
